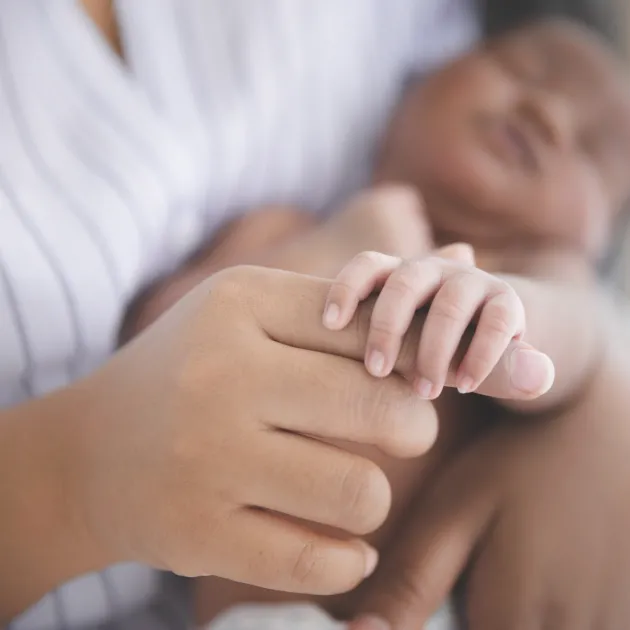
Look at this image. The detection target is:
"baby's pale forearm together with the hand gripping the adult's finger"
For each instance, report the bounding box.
[328,253,614,413]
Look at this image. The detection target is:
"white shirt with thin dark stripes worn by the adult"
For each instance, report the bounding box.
[0,0,477,630]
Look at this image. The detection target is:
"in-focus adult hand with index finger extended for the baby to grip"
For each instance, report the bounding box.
[73,268,540,594]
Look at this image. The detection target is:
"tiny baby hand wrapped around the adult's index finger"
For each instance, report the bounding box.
[324,246,553,399]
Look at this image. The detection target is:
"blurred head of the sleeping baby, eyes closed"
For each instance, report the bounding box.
[376,21,630,257]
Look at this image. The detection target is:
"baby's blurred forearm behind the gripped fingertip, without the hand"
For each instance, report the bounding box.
[502,276,614,413]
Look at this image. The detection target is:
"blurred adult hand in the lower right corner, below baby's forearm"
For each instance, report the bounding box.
[351,348,630,630]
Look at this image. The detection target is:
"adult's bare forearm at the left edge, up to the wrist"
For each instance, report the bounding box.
[0,390,106,626]
